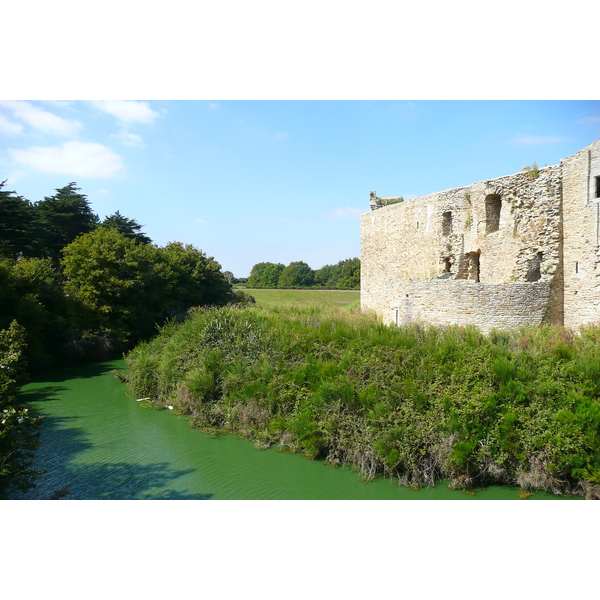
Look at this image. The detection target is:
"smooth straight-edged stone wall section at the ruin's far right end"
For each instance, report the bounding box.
[561,140,600,327]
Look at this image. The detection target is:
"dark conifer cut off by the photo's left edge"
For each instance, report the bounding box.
[0,180,34,259]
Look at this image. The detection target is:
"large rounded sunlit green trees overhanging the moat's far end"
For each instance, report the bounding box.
[62,227,233,350]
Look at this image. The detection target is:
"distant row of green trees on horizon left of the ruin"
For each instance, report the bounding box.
[246,258,360,290]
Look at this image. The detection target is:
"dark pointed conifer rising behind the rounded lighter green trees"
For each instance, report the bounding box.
[34,183,100,263]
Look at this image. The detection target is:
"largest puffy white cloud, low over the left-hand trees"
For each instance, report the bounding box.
[8,141,123,177]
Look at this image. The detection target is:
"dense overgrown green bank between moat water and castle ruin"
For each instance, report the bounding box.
[125,307,600,498]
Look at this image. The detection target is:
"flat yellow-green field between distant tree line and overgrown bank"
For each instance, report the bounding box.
[243,289,360,309]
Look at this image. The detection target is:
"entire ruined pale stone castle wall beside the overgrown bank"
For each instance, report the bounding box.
[361,140,600,332]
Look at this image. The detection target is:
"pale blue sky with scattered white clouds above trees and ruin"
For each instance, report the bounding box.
[0,100,600,277]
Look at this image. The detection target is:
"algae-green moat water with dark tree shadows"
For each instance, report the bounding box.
[10,360,572,500]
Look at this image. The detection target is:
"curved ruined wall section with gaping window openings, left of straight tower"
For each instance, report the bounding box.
[361,155,563,331]
